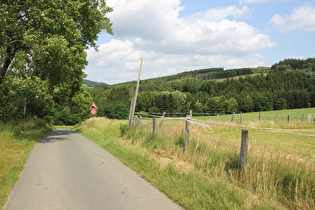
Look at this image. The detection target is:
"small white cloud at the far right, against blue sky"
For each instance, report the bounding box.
[270,4,315,32]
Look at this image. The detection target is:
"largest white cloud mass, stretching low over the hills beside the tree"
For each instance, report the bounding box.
[86,0,275,84]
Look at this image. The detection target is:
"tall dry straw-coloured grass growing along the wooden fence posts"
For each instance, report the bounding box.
[125,121,315,209]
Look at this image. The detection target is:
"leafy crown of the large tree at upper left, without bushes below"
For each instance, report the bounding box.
[0,0,112,96]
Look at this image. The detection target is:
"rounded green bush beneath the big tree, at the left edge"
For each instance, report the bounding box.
[0,76,54,122]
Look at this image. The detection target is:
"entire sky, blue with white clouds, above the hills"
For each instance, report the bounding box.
[85,0,315,84]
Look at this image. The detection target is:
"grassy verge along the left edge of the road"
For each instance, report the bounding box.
[0,120,52,207]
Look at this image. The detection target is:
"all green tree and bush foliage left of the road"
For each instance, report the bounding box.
[0,0,113,124]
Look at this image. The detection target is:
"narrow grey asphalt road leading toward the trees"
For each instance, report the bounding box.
[4,130,181,210]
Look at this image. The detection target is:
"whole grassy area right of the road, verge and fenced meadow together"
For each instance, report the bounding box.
[76,109,315,209]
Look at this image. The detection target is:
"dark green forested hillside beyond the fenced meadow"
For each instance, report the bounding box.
[88,59,315,119]
